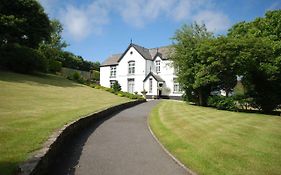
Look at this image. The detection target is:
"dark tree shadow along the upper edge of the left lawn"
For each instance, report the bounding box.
[0,71,82,87]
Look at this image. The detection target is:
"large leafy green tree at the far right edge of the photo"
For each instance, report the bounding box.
[228,10,281,112]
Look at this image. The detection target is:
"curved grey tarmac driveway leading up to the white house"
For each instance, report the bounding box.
[48,100,187,175]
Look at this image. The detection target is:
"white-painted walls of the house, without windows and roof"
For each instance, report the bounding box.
[100,47,182,96]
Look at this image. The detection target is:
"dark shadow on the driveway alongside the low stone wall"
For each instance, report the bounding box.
[46,113,117,175]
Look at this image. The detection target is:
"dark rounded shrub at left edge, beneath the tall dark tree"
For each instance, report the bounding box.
[0,44,48,73]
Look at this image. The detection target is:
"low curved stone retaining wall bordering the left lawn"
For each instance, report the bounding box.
[16,100,146,175]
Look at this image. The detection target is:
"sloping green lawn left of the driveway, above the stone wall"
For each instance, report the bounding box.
[0,71,129,175]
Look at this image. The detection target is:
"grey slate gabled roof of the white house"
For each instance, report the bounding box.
[101,43,172,66]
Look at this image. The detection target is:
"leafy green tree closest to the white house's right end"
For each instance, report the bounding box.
[171,23,213,105]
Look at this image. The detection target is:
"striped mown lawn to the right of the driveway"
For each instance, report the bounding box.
[149,100,281,175]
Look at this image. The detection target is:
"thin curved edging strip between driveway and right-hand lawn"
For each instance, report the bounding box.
[146,101,197,175]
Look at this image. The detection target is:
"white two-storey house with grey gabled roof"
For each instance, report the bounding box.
[100,44,182,99]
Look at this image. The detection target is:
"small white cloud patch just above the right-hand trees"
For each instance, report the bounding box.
[193,10,231,32]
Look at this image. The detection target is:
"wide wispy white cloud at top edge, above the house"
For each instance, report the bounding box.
[113,0,209,27]
